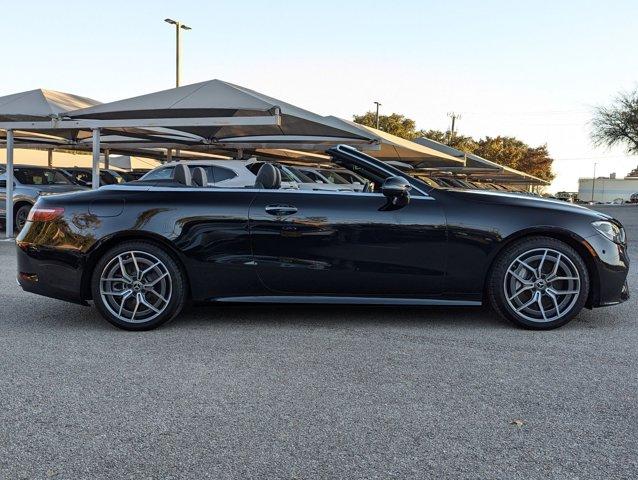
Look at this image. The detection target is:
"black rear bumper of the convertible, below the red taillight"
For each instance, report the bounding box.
[16,242,88,305]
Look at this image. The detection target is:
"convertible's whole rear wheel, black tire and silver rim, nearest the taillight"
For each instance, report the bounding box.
[91,241,188,331]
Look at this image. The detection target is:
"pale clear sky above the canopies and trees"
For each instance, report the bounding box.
[0,0,638,191]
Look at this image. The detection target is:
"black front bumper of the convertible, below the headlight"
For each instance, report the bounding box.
[587,235,630,307]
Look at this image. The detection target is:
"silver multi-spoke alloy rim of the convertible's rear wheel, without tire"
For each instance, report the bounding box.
[100,250,173,323]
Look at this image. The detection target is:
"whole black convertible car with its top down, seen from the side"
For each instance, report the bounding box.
[17,146,629,330]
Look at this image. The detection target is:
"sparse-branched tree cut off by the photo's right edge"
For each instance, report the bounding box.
[591,89,638,154]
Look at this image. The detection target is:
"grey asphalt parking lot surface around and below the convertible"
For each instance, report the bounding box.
[0,207,638,479]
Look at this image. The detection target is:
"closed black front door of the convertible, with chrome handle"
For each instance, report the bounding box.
[249,190,447,297]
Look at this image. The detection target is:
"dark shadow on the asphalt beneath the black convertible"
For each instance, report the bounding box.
[4,299,622,334]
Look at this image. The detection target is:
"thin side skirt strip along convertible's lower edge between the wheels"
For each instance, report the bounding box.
[212,295,483,307]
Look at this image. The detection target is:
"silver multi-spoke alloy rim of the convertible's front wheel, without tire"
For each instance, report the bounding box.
[503,248,581,322]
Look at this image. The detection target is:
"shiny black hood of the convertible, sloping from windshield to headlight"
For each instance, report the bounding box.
[445,188,611,219]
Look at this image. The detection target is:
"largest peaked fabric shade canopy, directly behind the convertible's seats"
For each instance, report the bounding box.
[68,80,374,148]
